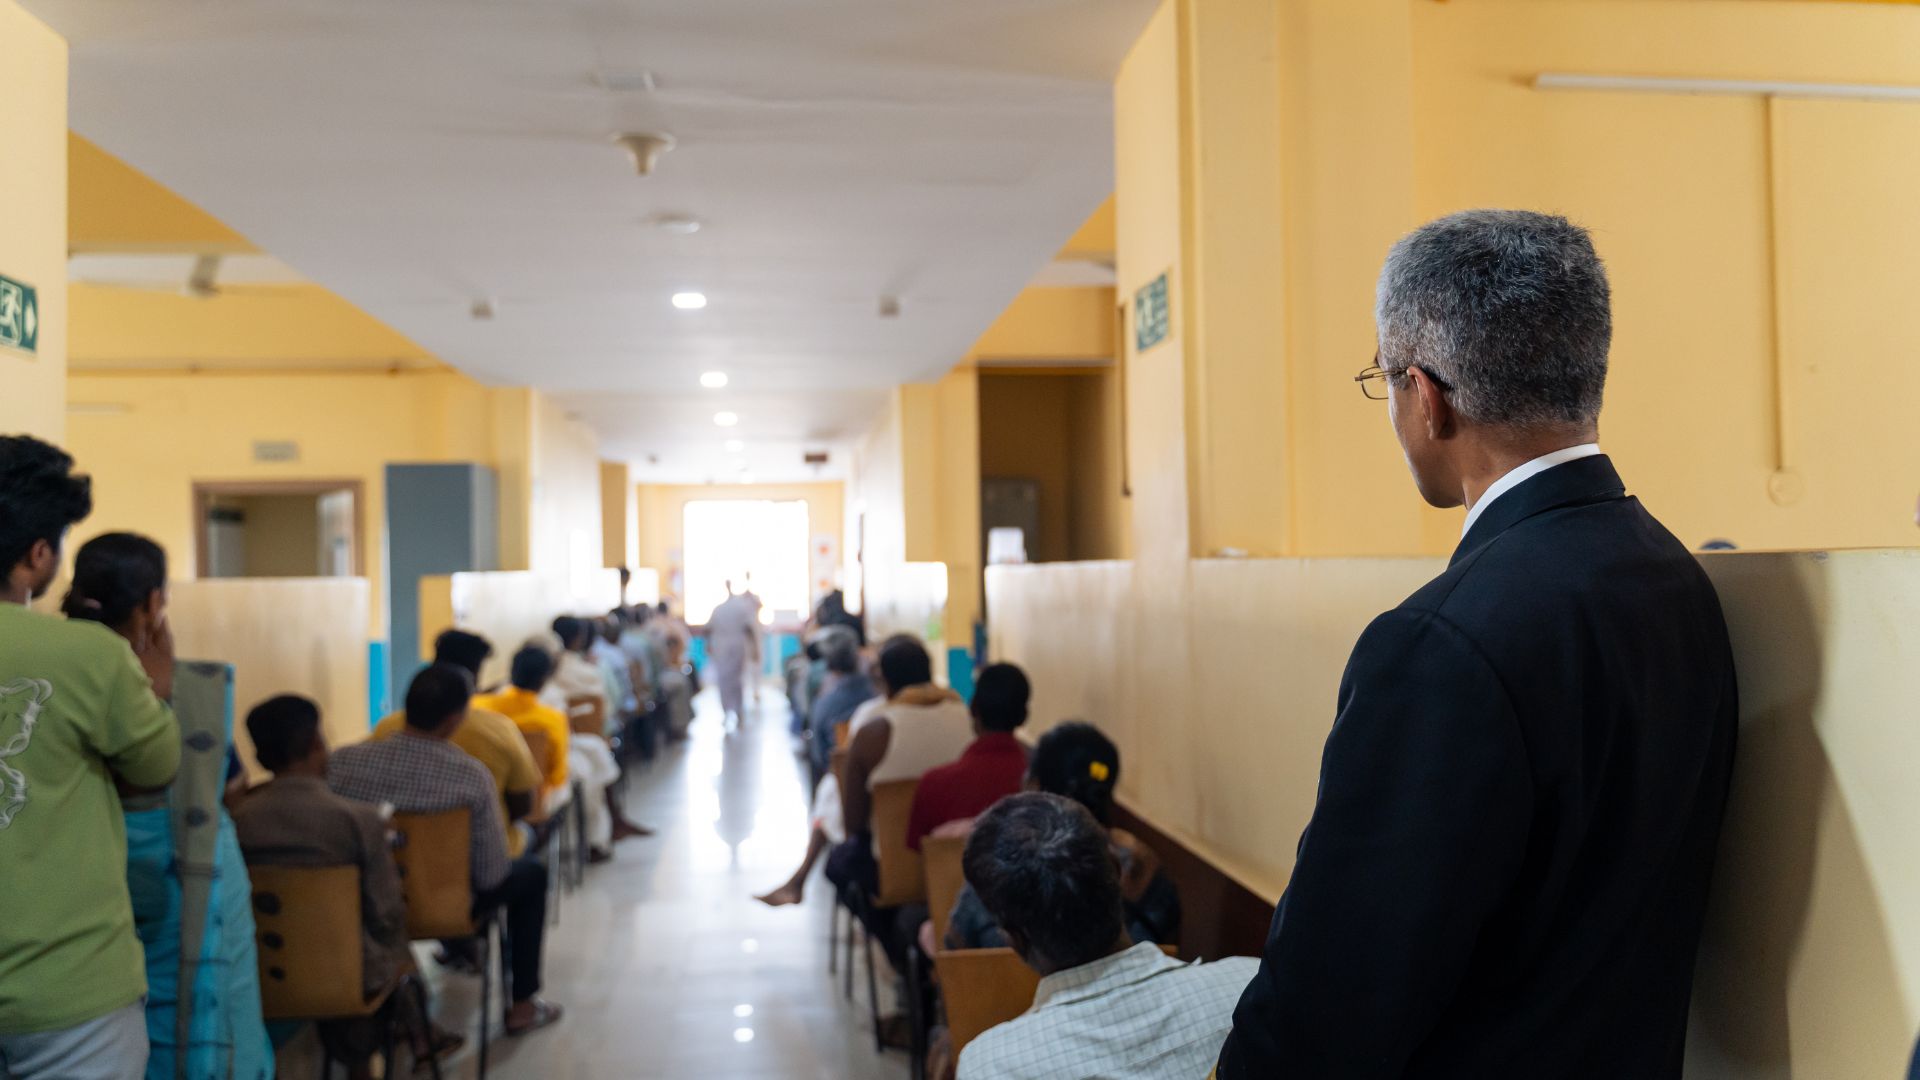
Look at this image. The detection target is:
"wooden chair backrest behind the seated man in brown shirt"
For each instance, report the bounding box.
[248,865,369,1020]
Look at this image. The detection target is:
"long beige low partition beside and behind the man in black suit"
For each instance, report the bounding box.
[987,552,1920,1080]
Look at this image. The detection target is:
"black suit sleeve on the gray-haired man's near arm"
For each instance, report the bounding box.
[1219,611,1532,1080]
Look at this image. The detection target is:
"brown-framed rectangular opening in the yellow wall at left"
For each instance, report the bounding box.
[194,480,367,578]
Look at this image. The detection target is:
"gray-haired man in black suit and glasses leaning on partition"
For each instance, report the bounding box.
[1219,211,1738,1080]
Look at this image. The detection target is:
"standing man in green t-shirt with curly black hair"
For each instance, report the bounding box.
[0,436,180,1080]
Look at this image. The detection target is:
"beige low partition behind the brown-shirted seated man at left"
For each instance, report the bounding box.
[167,578,372,778]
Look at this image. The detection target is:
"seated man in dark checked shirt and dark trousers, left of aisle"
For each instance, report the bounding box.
[326,663,561,1036]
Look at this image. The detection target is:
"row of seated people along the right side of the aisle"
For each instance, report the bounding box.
[758,628,1258,1080]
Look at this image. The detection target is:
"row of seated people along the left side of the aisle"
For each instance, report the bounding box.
[234,595,706,1074]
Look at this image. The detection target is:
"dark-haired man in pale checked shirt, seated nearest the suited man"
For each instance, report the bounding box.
[960,792,1260,1080]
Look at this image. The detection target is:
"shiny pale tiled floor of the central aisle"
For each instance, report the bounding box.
[282,686,906,1080]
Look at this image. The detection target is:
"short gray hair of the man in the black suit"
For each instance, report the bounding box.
[1373,209,1613,429]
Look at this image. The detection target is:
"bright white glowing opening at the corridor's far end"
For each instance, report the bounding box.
[682,500,812,625]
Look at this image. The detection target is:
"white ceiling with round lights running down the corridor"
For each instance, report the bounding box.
[25,0,1154,480]
